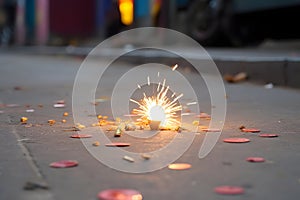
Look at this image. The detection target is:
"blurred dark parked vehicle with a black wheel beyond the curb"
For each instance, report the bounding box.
[186,0,300,46]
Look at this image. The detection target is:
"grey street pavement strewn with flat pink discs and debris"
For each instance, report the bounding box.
[0,53,300,200]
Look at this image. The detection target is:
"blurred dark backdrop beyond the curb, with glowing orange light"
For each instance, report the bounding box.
[0,0,300,47]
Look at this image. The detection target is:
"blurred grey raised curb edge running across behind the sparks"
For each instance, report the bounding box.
[0,46,300,88]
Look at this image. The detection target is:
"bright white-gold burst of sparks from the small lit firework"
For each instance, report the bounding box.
[130,78,183,129]
